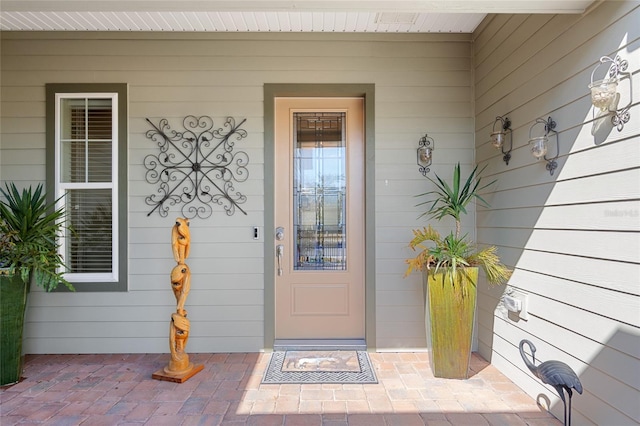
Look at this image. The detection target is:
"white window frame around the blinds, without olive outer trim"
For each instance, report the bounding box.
[55,92,120,283]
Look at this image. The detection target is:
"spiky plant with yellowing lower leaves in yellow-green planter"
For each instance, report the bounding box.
[406,163,511,284]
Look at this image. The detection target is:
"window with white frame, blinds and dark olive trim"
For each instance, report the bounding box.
[47,84,127,291]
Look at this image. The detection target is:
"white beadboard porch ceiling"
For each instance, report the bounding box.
[0,0,594,33]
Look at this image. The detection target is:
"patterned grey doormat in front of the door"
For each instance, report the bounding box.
[262,351,378,384]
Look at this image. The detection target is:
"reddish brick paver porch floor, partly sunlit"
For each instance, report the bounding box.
[0,353,561,426]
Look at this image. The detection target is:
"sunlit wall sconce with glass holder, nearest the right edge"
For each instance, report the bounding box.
[589,55,633,132]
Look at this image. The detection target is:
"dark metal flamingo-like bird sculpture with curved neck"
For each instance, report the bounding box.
[520,339,582,426]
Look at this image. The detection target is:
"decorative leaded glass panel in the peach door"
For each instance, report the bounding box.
[293,112,347,271]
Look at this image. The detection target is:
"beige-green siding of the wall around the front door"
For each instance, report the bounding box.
[0,32,474,353]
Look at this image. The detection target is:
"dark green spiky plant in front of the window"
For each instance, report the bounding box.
[0,183,74,291]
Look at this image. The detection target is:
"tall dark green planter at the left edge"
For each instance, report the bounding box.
[0,274,27,386]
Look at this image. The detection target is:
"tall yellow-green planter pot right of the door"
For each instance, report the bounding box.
[425,268,478,379]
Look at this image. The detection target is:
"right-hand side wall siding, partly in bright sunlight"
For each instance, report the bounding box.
[474,1,640,425]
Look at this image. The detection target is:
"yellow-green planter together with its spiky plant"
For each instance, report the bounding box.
[406,163,511,378]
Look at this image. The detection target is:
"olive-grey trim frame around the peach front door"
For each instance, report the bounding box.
[263,84,376,351]
